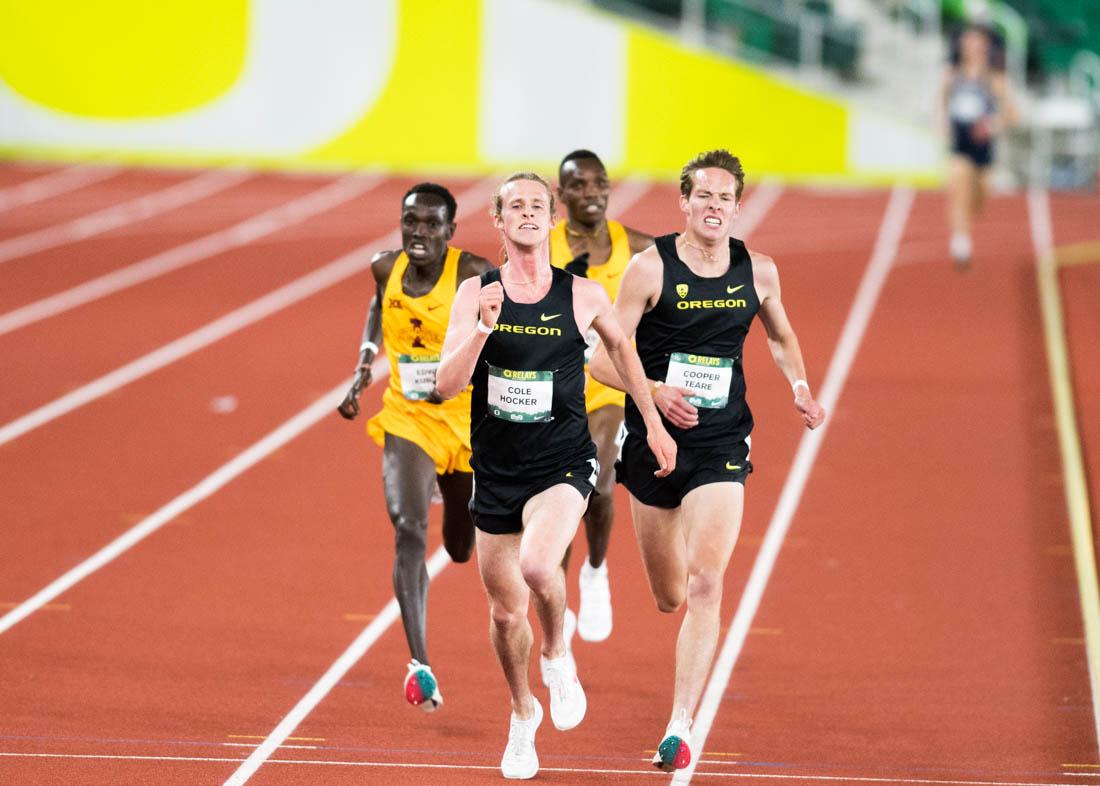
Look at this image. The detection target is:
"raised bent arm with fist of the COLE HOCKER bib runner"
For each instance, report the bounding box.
[436,277,504,399]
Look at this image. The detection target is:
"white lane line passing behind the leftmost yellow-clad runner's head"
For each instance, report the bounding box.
[0,180,491,445]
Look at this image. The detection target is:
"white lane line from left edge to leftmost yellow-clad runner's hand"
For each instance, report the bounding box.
[0,357,389,634]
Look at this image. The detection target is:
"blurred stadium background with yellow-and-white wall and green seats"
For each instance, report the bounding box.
[0,0,1100,188]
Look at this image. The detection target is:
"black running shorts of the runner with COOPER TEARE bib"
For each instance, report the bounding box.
[615,434,752,509]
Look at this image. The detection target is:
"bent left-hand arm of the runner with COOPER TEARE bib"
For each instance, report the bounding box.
[589,246,699,429]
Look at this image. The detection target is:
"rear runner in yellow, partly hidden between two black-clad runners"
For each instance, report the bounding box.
[550,150,653,641]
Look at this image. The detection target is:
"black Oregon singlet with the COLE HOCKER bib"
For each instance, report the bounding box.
[470,268,596,479]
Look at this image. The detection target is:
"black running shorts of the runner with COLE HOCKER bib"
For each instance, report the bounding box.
[470,457,600,535]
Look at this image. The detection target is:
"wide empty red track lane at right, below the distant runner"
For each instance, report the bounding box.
[690,195,1091,781]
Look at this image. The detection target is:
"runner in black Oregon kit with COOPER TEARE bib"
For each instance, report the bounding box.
[589,151,825,770]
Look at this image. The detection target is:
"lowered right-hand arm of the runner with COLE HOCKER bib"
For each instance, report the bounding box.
[573,278,677,477]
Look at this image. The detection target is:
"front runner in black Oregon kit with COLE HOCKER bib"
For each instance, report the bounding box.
[436,173,675,778]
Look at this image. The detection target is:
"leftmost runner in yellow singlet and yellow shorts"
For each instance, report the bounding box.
[339,182,492,712]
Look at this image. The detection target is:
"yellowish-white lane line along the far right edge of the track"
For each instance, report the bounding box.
[1027,189,1100,751]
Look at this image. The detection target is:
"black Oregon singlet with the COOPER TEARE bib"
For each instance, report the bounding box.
[626,234,760,446]
